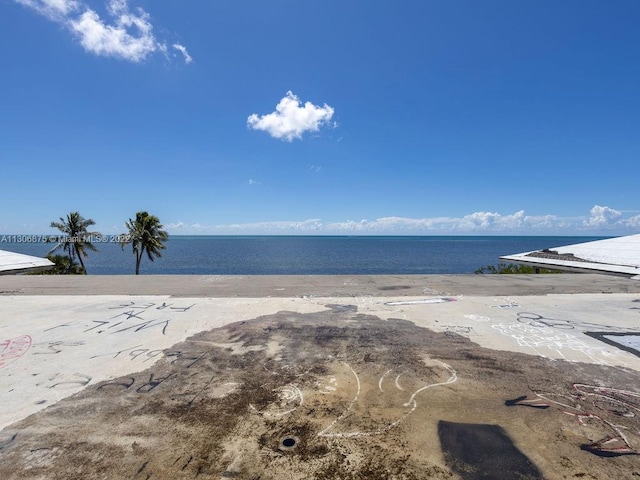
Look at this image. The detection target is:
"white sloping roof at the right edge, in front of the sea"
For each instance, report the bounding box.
[500,234,640,279]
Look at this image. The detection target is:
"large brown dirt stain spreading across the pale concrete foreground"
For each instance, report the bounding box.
[0,305,640,480]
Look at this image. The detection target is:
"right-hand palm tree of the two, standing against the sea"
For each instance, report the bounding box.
[120,212,169,275]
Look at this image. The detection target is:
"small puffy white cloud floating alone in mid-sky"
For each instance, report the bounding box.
[247,91,334,142]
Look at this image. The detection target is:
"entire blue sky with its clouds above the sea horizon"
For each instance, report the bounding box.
[0,0,640,235]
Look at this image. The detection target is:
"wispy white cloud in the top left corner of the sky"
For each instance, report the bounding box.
[14,0,193,63]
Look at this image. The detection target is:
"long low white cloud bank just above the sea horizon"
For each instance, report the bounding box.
[165,205,640,236]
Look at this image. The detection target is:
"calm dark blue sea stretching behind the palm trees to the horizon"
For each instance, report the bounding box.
[0,235,606,275]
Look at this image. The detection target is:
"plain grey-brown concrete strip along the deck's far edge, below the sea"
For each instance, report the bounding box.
[0,274,640,298]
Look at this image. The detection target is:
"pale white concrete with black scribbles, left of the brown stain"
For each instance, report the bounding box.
[0,295,322,428]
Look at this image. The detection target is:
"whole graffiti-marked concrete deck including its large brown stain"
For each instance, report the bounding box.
[0,275,640,479]
